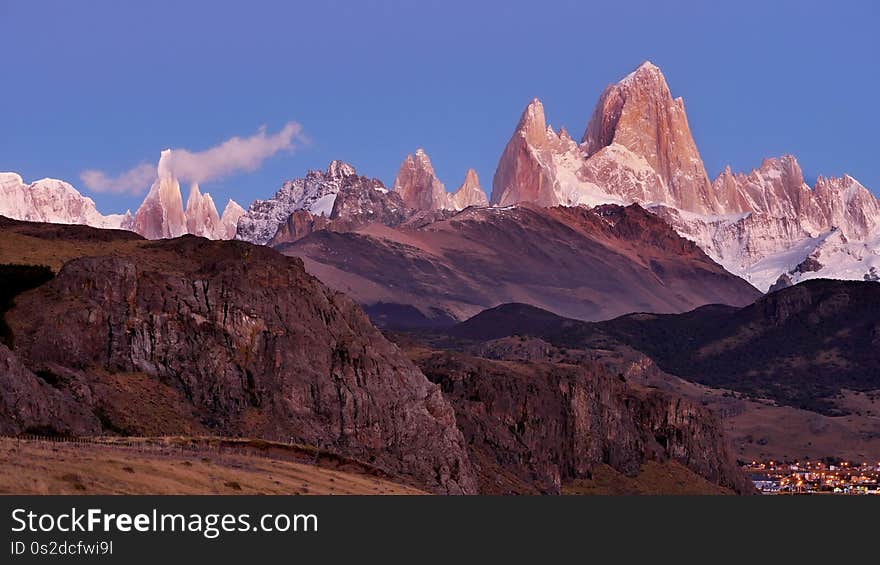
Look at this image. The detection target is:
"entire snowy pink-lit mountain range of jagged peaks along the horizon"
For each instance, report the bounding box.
[0,62,880,302]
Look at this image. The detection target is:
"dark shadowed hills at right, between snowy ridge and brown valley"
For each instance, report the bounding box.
[450,280,880,414]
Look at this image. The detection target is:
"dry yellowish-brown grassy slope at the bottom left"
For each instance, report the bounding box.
[0,439,423,494]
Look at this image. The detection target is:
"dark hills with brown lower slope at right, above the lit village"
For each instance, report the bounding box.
[434,280,880,461]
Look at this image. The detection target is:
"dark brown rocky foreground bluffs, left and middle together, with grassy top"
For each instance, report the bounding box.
[0,219,748,494]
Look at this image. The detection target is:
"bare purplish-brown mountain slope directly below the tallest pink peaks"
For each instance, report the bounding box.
[277,205,759,328]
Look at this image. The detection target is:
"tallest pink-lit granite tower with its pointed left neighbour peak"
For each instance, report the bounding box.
[491,63,714,213]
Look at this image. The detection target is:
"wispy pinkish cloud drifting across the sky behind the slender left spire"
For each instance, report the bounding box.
[80,122,308,194]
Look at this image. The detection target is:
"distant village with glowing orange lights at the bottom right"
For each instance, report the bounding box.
[743,459,880,495]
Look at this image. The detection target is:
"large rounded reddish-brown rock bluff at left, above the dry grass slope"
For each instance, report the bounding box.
[6,237,476,493]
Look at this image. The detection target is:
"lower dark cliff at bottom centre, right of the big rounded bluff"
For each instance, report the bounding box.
[418,353,751,494]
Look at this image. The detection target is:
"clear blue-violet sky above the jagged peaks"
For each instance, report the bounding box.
[0,0,880,213]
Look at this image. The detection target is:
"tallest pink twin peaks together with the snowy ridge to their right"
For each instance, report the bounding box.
[490,62,880,290]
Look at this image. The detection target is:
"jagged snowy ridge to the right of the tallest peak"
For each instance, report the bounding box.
[653,159,880,291]
